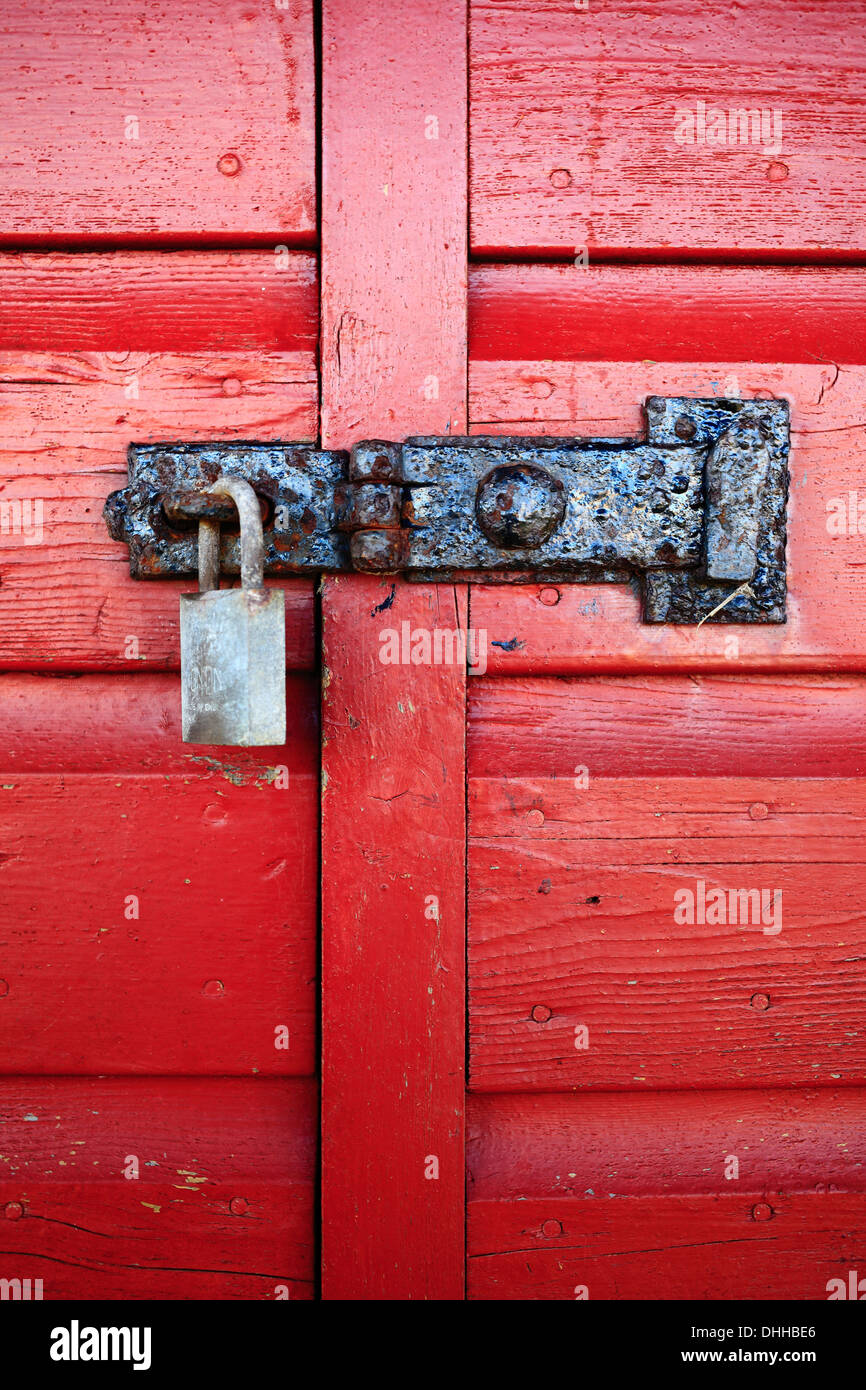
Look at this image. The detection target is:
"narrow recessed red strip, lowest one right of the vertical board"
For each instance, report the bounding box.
[466,1088,866,1202]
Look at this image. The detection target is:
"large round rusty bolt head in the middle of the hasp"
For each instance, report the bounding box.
[475,463,566,550]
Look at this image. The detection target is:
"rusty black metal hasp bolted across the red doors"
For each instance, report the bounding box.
[106,396,790,624]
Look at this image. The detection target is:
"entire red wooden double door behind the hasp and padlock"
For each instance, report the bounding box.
[0,0,866,1300]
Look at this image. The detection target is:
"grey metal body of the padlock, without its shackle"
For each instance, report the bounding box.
[181,589,286,748]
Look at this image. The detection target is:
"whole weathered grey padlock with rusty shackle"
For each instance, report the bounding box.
[181,477,286,748]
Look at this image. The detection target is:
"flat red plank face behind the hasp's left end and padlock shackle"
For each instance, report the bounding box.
[0,350,317,673]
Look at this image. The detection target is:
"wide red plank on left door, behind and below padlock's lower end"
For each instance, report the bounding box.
[0,676,318,1077]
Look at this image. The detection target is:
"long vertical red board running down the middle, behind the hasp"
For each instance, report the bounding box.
[321,0,467,1300]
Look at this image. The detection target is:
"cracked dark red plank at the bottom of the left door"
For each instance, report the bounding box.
[0,1077,317,1301]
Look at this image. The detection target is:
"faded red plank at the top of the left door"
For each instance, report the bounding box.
[0,0,316,245]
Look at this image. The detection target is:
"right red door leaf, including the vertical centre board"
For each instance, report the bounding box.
[322,0,866,1300]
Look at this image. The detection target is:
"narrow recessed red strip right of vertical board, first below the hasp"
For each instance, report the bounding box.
[468,676,866,787]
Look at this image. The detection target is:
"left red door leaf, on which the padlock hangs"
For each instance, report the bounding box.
[0,0,318,1300]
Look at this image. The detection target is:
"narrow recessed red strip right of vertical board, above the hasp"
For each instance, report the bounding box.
[468,265,866,364]
